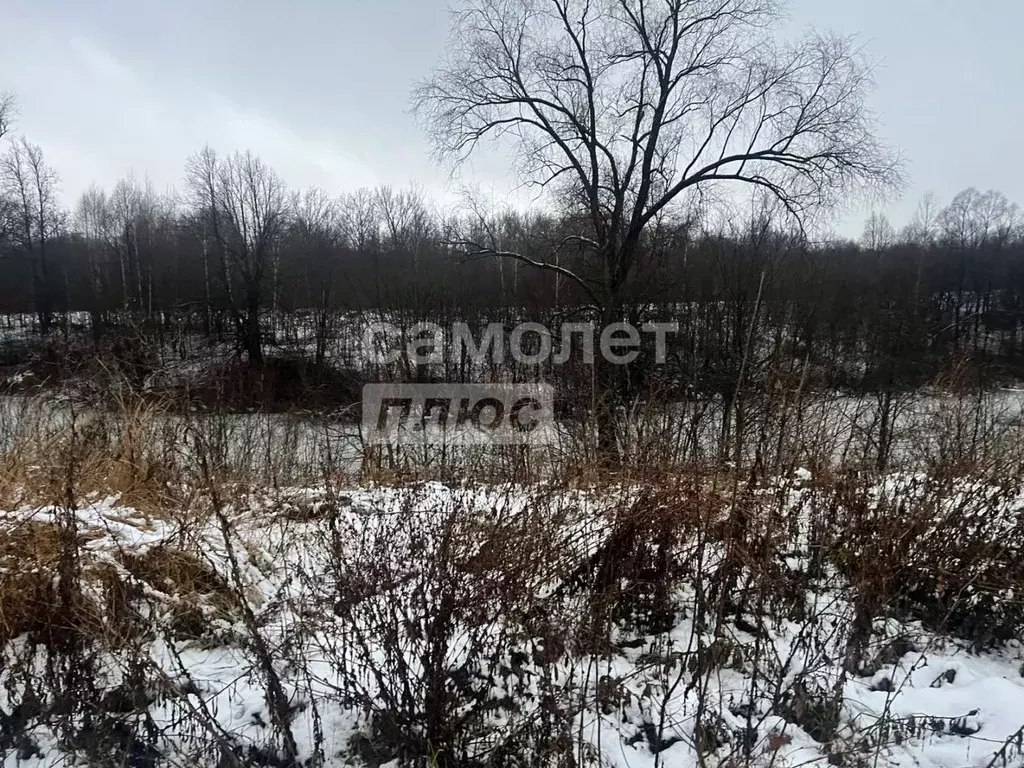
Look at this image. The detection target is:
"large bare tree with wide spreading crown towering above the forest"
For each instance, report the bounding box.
[415,0,899,321]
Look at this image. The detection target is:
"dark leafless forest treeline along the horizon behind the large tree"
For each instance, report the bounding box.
[0,128,1024,392]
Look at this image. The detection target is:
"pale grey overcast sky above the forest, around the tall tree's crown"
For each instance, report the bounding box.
[0,0,1024,234]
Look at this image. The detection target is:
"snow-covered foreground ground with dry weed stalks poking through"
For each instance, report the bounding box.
[0,479,1024,768]
